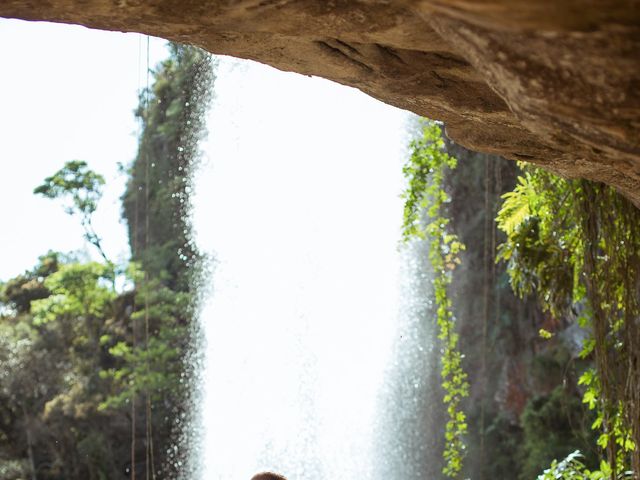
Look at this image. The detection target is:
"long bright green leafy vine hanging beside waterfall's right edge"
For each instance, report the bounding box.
[403,121,469,478]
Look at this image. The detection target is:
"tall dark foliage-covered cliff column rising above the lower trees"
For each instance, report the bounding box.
[122,44,214,291]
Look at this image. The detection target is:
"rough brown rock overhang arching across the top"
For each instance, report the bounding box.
[0,0,640,204]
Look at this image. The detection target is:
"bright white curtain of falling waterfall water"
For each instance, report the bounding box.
[193,58,440,480]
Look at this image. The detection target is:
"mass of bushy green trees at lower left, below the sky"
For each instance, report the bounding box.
[0,253,191,479]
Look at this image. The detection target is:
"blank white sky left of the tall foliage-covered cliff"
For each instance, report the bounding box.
[0,19,166,280]
